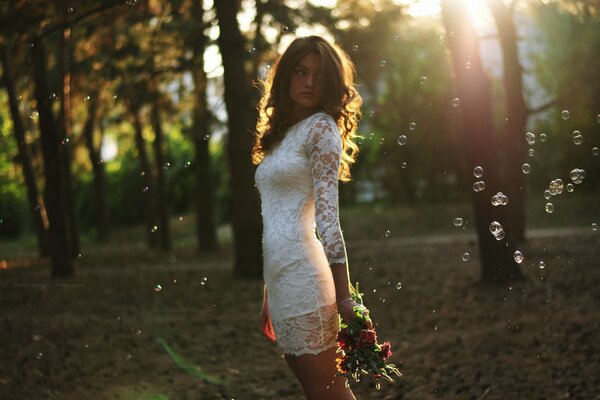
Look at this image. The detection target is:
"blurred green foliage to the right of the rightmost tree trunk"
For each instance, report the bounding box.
[529,2,600,191]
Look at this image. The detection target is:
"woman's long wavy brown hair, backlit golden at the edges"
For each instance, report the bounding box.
[252,36,362,182]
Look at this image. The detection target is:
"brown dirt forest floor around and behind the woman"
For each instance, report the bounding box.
[0,230,600,400]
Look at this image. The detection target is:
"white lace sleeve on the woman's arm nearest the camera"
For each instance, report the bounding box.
[305,115,346,266]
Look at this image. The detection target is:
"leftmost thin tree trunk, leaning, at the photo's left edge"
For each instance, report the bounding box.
[2,43,50,257]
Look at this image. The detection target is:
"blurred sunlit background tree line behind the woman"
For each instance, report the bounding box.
[0,0,600,282]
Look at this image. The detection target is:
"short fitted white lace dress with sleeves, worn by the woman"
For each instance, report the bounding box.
[255,112,346,355]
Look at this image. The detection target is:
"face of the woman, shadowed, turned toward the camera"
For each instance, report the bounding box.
[290,53,324,114]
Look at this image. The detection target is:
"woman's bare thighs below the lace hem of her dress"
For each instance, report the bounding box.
[285,347,356,400]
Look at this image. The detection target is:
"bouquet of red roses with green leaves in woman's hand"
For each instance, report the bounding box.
[336,283,402,390]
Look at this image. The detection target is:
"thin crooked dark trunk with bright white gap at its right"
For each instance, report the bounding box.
[83,93,110,243]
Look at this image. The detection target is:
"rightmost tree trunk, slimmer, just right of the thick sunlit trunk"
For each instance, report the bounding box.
[488,0,529,244]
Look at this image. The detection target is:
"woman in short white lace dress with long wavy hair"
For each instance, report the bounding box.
[252,36,372,400]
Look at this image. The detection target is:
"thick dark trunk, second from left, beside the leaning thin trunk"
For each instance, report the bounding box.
[33,38,75,277]
